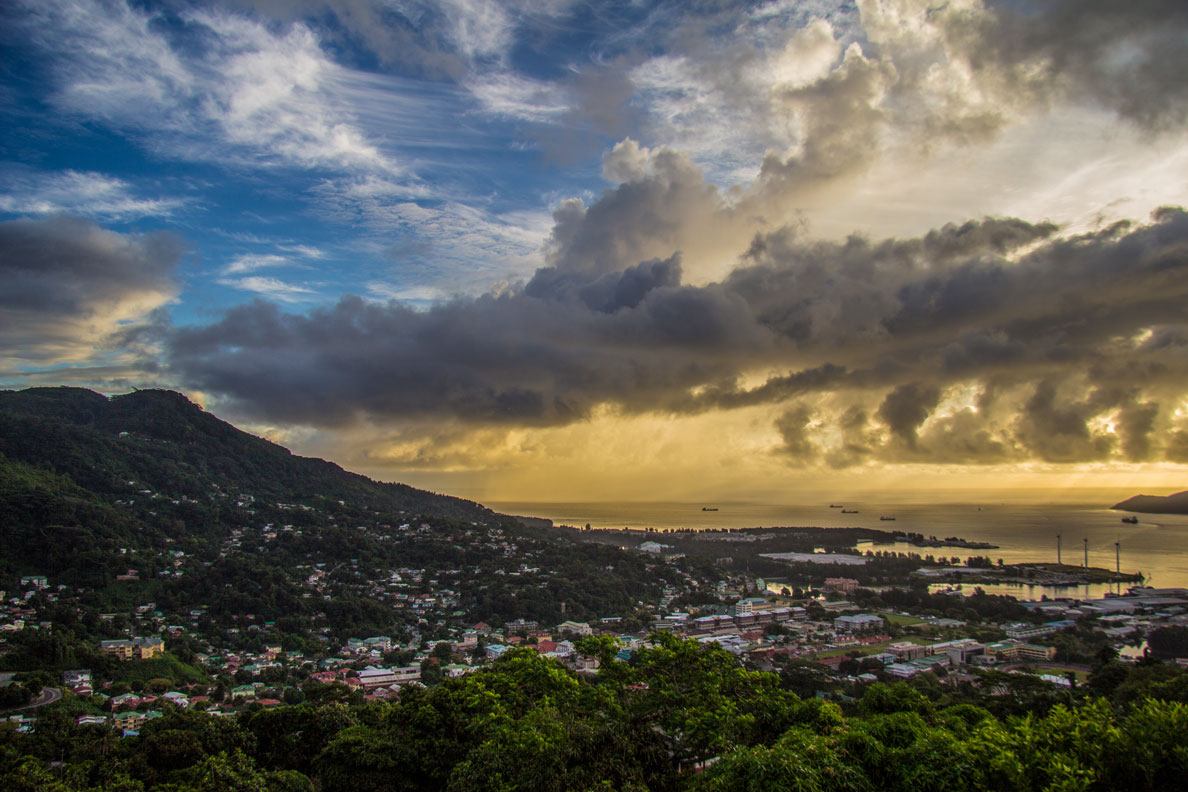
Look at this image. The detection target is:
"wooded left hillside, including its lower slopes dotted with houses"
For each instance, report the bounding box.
[0,388,689,645]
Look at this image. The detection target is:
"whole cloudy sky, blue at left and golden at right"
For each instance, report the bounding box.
[0,0,1188,502]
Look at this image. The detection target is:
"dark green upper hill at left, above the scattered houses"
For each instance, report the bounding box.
[0,387,498,584]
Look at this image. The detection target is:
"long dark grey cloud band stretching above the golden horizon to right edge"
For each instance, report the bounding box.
[169,204,1188,467]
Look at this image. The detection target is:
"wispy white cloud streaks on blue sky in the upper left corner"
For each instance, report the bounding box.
[27,0,402,175]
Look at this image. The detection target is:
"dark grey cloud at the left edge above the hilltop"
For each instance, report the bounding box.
[0,217,182,362]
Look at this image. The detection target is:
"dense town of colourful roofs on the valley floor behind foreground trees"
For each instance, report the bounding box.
[0,539,1188,735]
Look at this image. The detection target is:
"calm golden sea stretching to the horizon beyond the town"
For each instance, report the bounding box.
[487,502,1188,598]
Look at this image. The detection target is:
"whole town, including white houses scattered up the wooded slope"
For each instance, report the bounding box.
[0,508,1188,736]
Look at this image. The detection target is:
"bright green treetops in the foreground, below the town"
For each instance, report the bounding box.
[0,634,1188,792]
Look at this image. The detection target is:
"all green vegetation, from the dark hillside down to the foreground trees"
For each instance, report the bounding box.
[0,388,1188,792]
